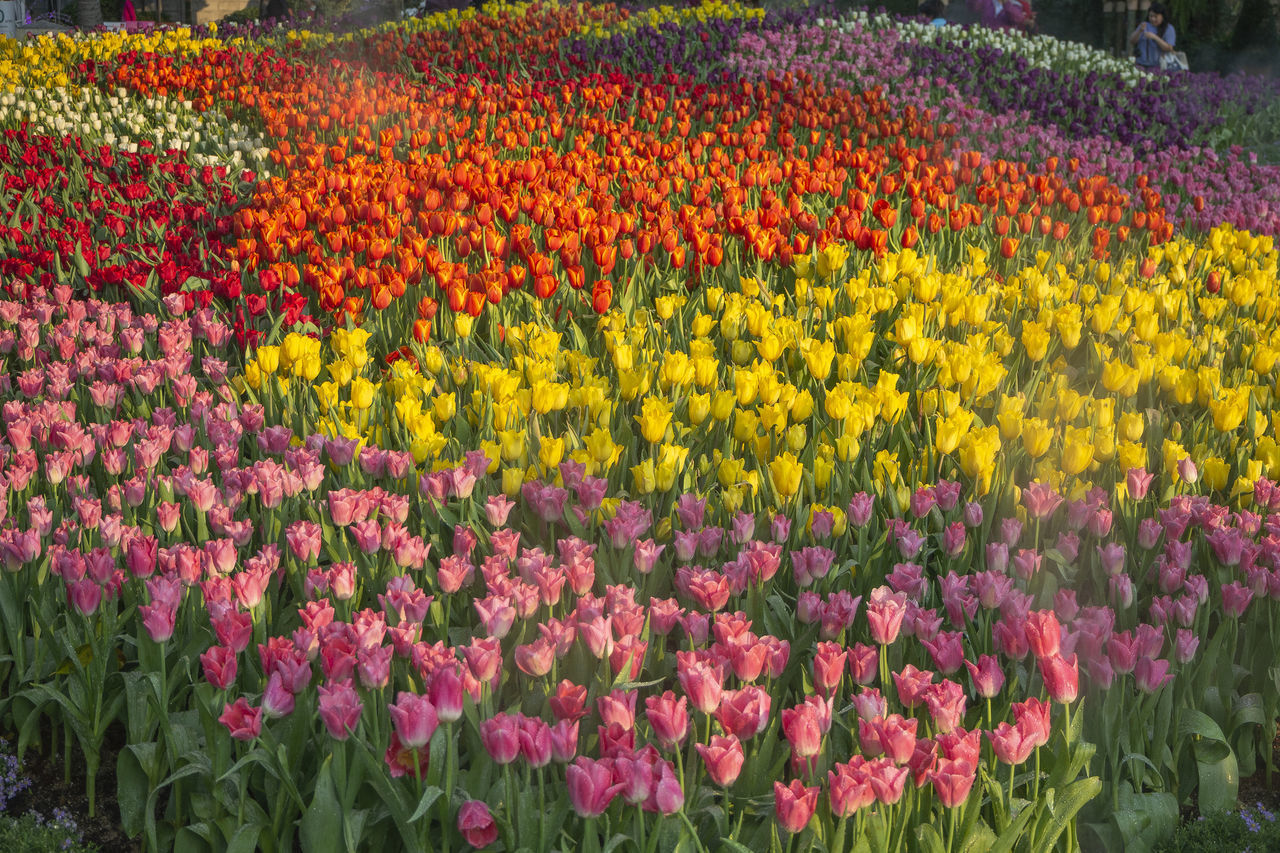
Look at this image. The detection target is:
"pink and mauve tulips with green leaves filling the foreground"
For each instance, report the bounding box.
[0,267,1280,849]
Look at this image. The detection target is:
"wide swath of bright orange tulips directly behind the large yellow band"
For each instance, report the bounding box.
[90,26,1172,341]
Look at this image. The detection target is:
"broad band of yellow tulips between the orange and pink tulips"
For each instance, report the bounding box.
[246,227,1280,514]
